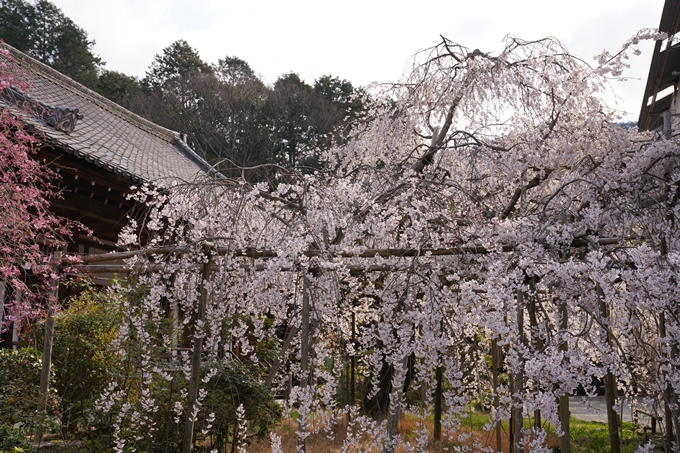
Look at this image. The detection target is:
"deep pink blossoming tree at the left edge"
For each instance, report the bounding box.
[0,47,77,322]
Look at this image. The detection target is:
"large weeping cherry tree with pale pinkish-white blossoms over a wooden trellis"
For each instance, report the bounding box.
[94,32,680,452]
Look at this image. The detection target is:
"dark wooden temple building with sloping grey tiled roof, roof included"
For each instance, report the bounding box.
[0,46,212,253]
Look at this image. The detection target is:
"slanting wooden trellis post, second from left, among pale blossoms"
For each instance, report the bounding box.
[182,256,212,453]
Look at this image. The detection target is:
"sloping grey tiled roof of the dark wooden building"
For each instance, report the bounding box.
[0,42,212,186]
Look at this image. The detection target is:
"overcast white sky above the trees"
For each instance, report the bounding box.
[52,0,664,120]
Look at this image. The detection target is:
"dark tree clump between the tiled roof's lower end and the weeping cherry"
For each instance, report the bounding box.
[127,41,366,181]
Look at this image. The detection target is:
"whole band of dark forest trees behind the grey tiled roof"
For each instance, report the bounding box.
[0,0,369,181]
